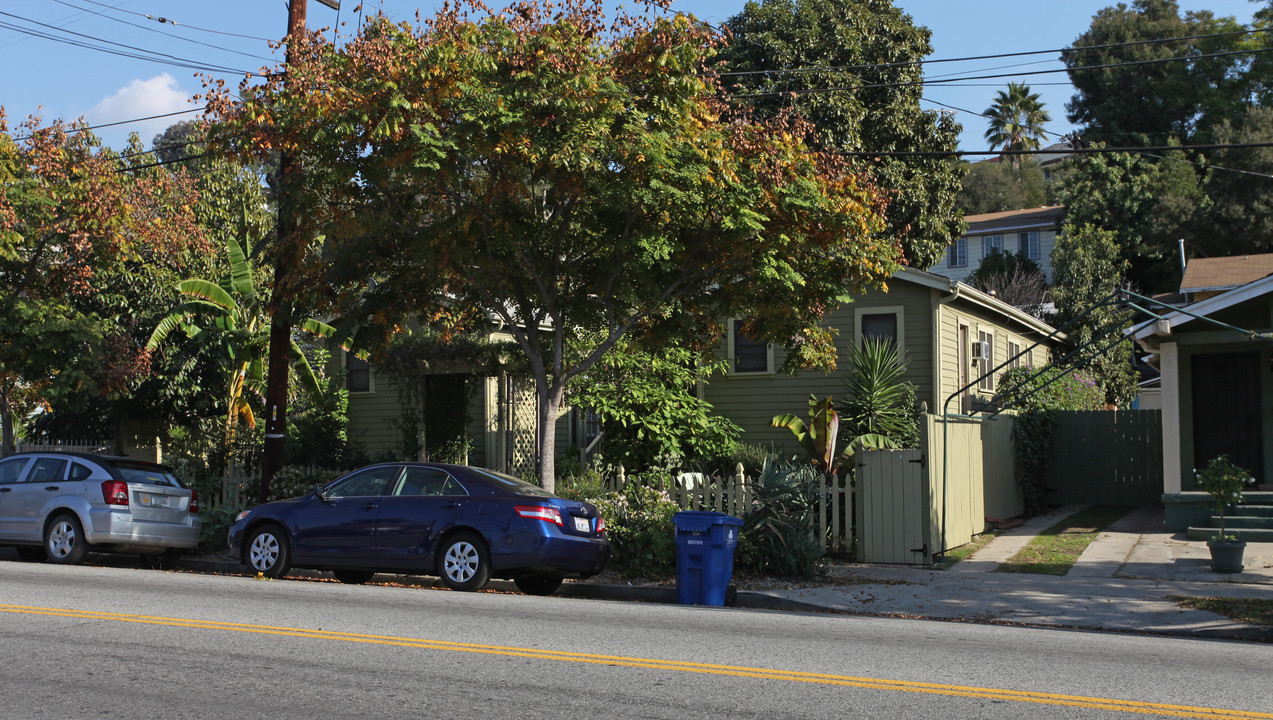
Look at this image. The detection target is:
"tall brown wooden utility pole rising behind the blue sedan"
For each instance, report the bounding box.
[257,0,308,502]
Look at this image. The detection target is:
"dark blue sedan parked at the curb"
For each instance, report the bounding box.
[229,463,610,595]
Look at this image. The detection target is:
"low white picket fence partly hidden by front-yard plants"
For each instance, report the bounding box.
[605,463,854,555]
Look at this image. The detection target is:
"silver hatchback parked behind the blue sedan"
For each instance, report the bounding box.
[0,453,202,566]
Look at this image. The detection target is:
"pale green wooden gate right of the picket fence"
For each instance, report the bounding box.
[855,450,933,565]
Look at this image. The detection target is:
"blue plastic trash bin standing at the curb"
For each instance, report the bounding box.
[672,510,742,607]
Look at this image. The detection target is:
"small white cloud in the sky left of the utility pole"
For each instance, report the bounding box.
[84,73,199,149]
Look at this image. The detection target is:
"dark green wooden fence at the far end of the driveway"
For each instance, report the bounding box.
[1048,410,1162,506]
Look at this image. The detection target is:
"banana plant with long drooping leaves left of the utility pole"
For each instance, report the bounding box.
[146,238,336,445]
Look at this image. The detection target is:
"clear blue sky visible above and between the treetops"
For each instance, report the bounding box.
[0,0,1259,150]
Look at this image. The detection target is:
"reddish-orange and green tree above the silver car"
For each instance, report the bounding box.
[0,111,209,449]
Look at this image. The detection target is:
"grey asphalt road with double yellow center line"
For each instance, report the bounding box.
[0,562,1273,720]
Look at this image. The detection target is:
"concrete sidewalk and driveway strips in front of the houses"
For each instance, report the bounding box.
[743,506,1273,641]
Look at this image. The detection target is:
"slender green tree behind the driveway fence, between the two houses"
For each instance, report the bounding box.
[1051,220,1137,407]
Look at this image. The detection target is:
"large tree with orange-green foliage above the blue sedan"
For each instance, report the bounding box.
[209,3,899,488]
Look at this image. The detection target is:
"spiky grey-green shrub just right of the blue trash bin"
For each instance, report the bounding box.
[737,460,826,579]
